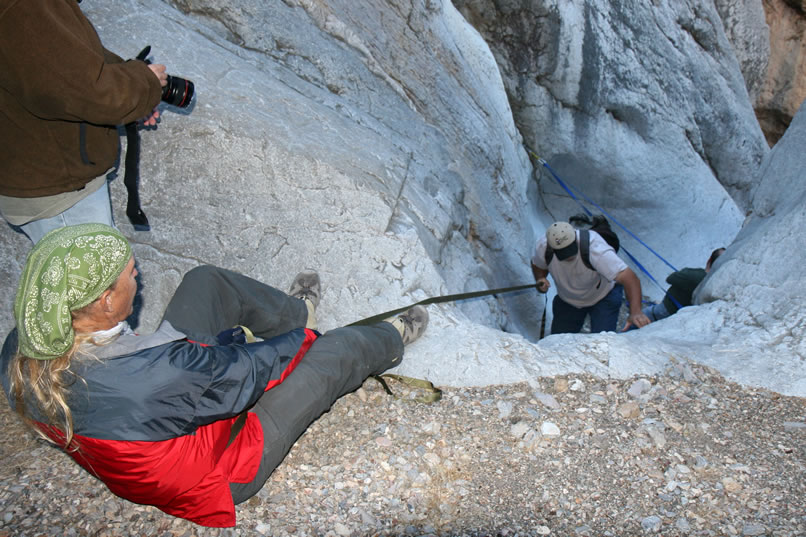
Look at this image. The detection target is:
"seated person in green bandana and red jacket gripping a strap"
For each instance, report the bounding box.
[0,224,428,527]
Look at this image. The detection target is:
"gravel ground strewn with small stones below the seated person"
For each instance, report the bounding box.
[0,365,806,537]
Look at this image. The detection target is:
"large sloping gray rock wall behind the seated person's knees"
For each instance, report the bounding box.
[0,0,542,335]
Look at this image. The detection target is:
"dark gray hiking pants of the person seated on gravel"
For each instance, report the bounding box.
[163,266,403,504]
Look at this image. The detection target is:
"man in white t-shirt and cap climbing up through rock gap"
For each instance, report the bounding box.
[532,222,650,334]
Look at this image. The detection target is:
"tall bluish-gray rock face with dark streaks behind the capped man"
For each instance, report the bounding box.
[456,0,767,272]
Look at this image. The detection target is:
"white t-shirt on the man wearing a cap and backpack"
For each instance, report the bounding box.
[532,231,627,308]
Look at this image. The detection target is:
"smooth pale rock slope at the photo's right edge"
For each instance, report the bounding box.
[695,101,806,376]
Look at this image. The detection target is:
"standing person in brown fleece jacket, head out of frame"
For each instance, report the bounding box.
[0,0,168,243]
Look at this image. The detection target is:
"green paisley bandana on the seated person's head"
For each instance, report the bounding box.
[14,224,132,360]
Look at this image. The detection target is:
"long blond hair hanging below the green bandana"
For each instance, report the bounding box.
[8,304,100,451]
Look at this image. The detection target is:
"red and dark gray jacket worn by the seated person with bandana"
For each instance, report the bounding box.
[0,328,317,527]
